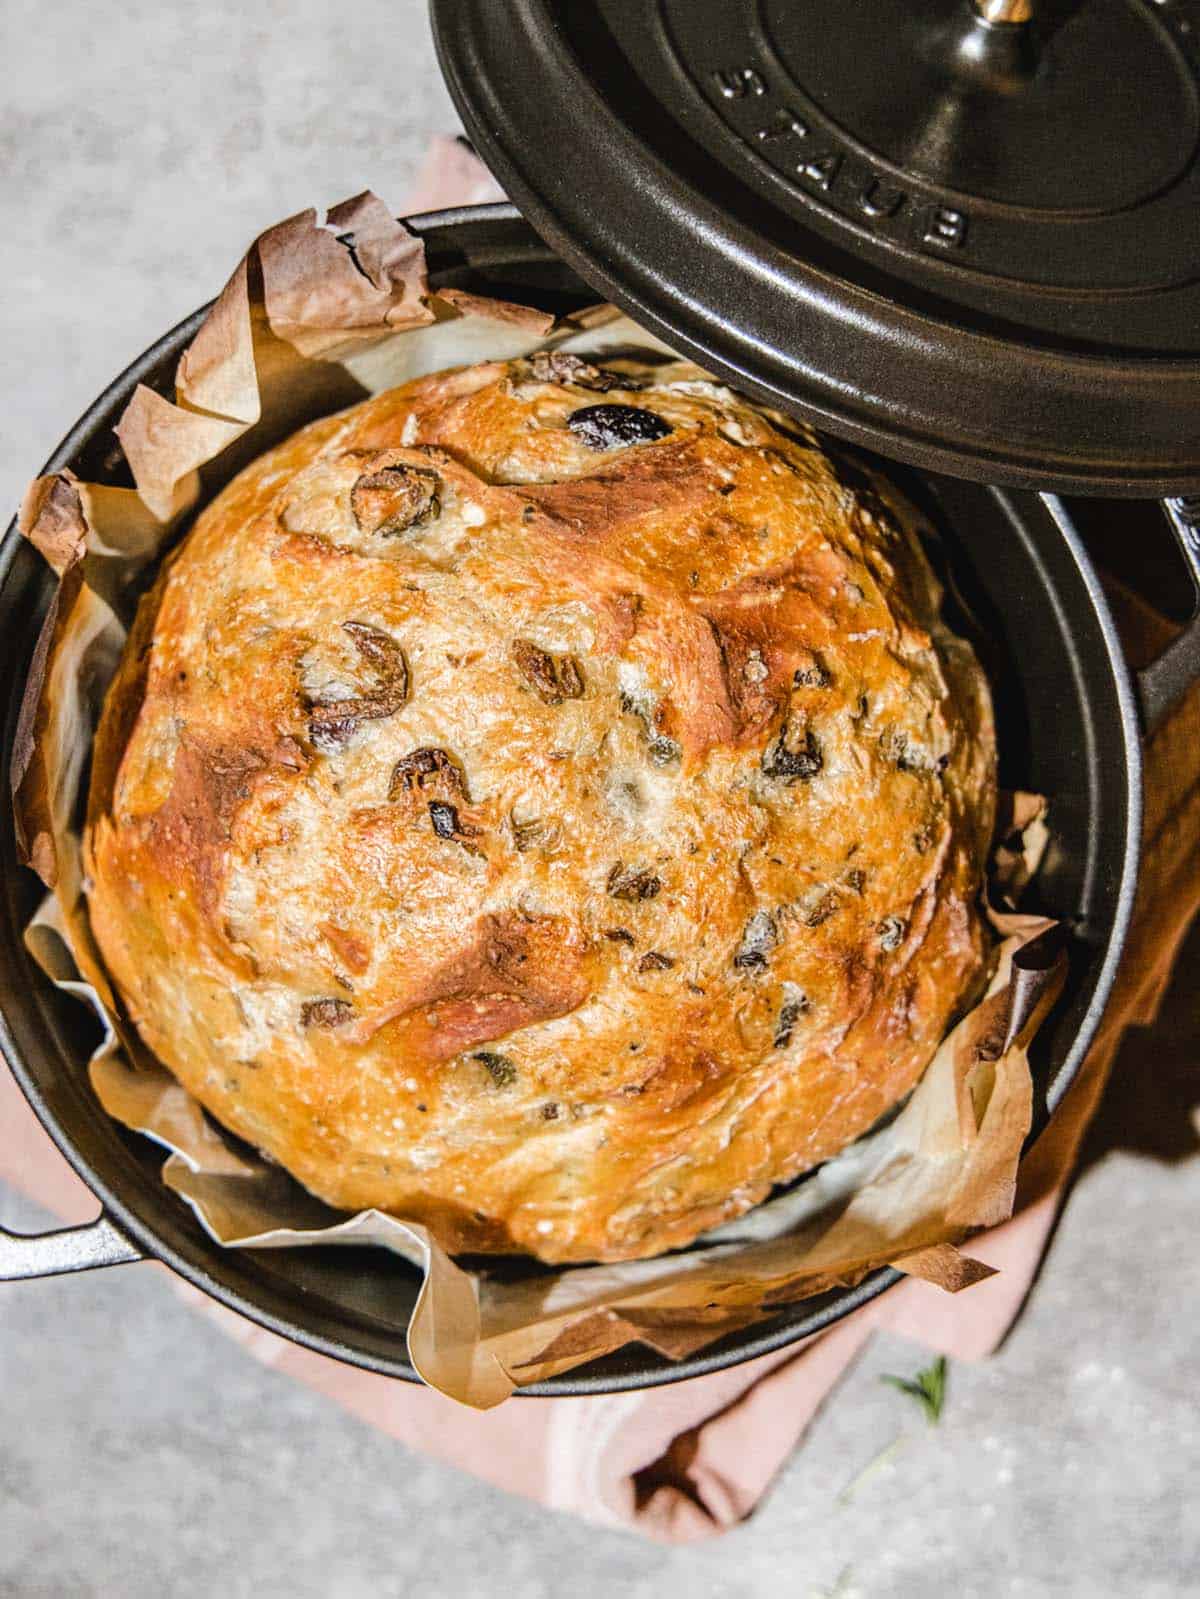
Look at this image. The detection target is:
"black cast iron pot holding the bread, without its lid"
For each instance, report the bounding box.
[0,205,1200,1394]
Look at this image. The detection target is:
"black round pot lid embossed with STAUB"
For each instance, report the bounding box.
[430,0,1200,496]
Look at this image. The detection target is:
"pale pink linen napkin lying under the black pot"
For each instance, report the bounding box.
[0,139,1200,1543]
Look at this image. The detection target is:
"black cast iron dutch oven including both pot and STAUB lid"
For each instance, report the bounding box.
[0,0,1200,1394]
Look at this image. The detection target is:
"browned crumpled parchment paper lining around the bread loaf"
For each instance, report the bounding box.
[13,193,1064,1409]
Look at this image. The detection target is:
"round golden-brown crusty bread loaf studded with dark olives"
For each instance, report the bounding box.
[86,353,995,1262]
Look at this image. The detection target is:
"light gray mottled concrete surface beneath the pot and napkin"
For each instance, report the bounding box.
[0,0,1200,1599]
